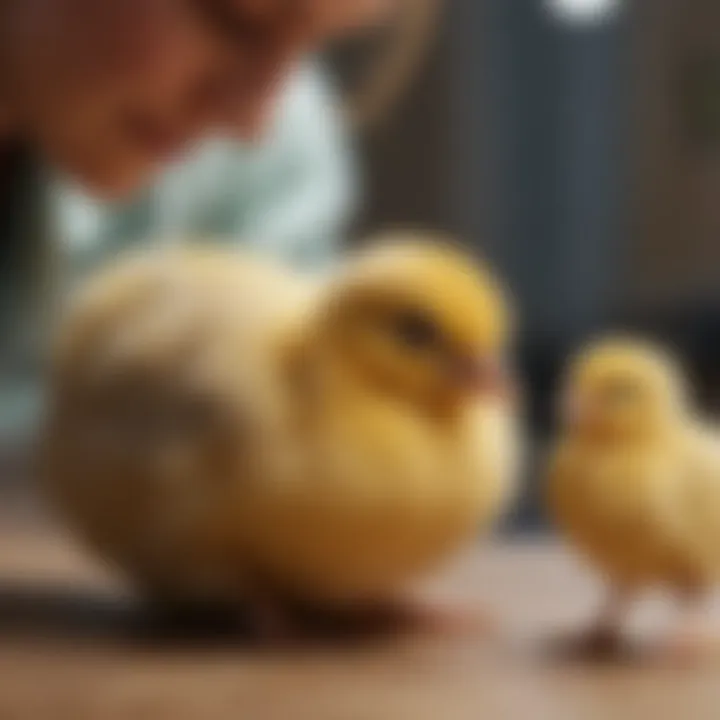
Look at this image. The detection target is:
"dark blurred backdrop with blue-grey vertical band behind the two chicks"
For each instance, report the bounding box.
[342,0,720,528]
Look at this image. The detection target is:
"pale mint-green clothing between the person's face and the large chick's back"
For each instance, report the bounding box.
[57,62,358,276]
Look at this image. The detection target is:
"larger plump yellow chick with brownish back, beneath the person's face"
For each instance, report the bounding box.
[45,235,521,632]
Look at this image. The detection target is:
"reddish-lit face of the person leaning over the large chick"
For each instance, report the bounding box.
[9,0,393,195]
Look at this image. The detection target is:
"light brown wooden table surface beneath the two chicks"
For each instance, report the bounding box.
[0,512,720,720]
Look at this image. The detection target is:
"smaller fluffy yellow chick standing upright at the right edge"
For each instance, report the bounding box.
[548,337,720,650]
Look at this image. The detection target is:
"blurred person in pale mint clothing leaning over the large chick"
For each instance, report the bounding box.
[0,0,400,462]
